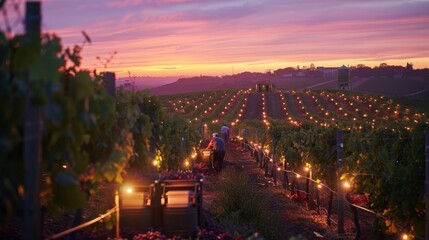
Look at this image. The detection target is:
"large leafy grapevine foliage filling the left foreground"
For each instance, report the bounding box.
[0,29,149,225]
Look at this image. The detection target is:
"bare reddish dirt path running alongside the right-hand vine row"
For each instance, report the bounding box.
[203,143,337,240]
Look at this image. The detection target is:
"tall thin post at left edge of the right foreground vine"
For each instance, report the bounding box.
[337,130,344,239]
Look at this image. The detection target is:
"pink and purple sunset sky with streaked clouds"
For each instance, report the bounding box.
[0,0,429,76]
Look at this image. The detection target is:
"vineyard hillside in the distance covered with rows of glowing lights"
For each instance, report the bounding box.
[161,89,429,127]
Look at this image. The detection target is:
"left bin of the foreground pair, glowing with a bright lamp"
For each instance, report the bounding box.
[119,183,154,232]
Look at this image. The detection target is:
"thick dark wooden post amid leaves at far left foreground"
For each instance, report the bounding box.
[23,2,42,240]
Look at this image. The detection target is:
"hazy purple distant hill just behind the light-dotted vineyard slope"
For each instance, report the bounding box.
[151,71,429,99]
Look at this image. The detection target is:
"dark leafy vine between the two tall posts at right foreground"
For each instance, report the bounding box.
[346,124,427,236]
